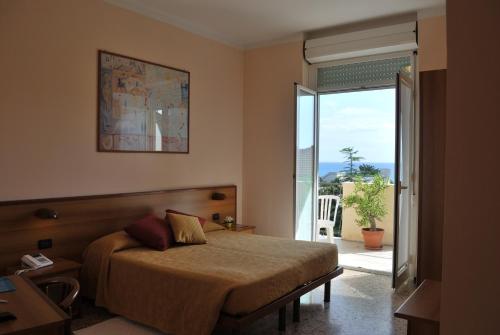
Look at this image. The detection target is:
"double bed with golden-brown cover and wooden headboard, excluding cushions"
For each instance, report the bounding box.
[0,185,342,335]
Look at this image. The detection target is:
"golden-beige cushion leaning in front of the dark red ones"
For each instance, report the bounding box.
[167,213,207,244]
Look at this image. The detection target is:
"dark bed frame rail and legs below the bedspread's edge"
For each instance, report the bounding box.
[216,266,344,335]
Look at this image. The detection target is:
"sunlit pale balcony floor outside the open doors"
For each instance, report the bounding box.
[335,238,392,275]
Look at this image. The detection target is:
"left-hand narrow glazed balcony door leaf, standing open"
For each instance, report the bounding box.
[294,84,317,241]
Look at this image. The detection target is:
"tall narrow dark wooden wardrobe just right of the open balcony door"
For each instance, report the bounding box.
[417,70,448,284]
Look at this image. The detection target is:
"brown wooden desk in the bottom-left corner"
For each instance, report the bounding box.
[0,276,70,335]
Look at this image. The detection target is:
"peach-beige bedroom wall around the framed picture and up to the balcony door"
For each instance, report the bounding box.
[0,0,446,237]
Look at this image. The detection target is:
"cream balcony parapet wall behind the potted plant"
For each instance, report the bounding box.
[342,183,394,245]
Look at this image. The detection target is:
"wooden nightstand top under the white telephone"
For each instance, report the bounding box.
[7,258,82,283]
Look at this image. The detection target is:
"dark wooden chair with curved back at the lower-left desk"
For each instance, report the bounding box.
[36,277,80,334]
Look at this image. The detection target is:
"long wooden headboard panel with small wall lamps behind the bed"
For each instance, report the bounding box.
[0,185,236,274]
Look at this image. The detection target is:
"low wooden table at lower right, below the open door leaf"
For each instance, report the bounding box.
[394,279,441,335]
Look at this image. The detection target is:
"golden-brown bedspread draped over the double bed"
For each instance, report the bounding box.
[82,231,337,335]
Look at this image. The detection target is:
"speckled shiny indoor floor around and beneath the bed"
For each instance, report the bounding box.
[73,270,411,335]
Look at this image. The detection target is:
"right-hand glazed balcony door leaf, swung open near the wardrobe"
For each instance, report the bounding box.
[392,72,414,289]
